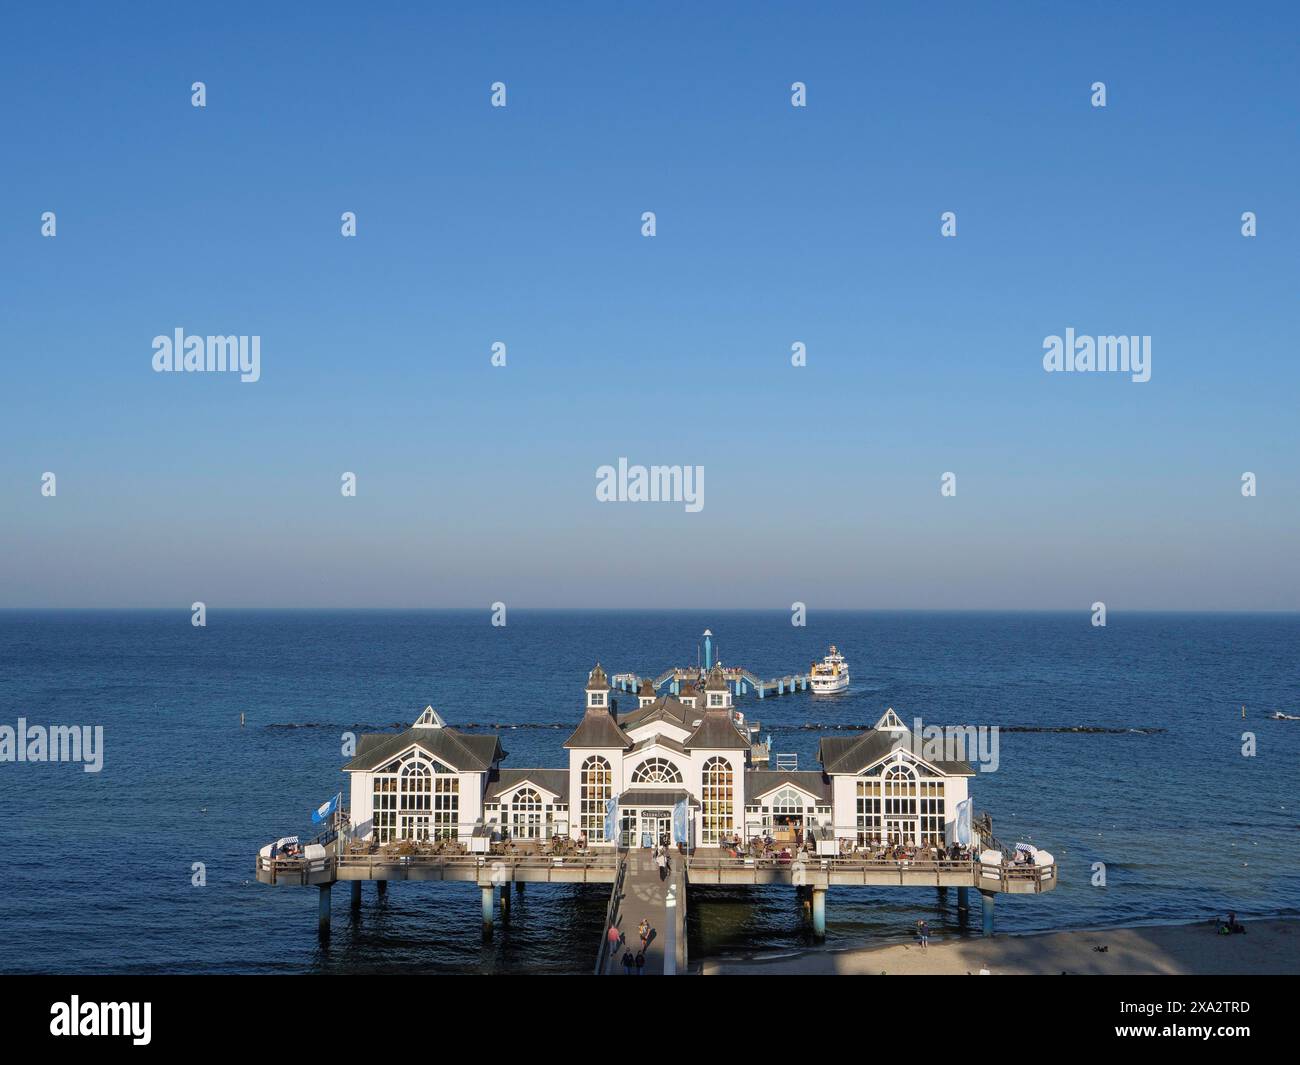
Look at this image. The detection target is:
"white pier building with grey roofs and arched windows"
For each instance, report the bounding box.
[346,686,972,847]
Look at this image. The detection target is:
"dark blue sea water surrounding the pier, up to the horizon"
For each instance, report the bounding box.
[0,610,1300,973]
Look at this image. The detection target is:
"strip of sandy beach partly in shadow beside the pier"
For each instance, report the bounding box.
[702,921,1300,977]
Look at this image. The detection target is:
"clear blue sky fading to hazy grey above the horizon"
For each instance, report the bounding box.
[0,0,1300,610]
